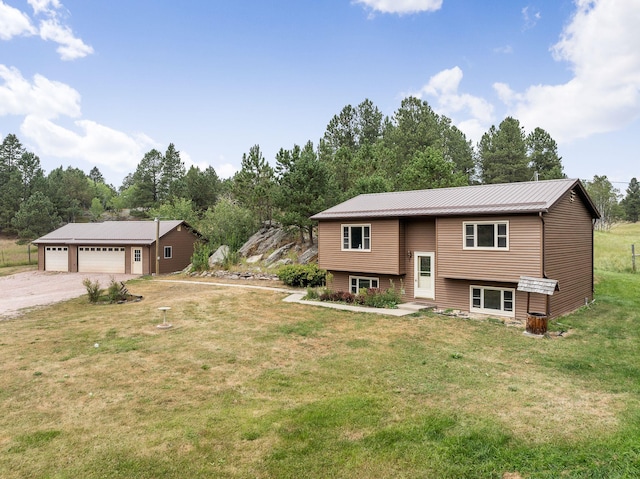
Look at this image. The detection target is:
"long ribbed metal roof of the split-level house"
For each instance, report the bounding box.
[311,179,600,220]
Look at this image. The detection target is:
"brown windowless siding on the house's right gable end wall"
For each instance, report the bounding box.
[544,191,593,316]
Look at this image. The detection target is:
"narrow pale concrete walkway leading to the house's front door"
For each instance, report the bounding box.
[153,279,429,316]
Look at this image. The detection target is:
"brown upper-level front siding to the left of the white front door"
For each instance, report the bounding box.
[318,219,404,275]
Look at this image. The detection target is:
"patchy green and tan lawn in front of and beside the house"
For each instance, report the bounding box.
[0,226,640,478]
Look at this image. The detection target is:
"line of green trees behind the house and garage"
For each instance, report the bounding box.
[0,97,640,248]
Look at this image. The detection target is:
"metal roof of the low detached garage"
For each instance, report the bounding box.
[33,220,184,245]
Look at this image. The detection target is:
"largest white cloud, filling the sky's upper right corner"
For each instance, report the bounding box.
[494,0,640,143]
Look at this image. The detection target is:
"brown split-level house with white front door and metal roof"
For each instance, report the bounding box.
[312,179,599,319]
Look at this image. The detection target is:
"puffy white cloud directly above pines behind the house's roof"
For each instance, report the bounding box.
[412,66,493,141]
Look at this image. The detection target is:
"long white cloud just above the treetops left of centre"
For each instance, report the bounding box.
[20,115,157,173]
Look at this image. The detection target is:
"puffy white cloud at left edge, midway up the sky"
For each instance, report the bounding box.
[0,64,80,118]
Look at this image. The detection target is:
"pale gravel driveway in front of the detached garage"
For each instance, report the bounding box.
[0,271,137,320]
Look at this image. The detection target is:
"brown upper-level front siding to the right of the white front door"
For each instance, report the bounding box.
[436,215,542,284]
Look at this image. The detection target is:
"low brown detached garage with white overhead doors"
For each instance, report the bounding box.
[33,220,199,274]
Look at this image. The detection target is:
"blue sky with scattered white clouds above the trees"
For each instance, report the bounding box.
[0,0,640,191]
